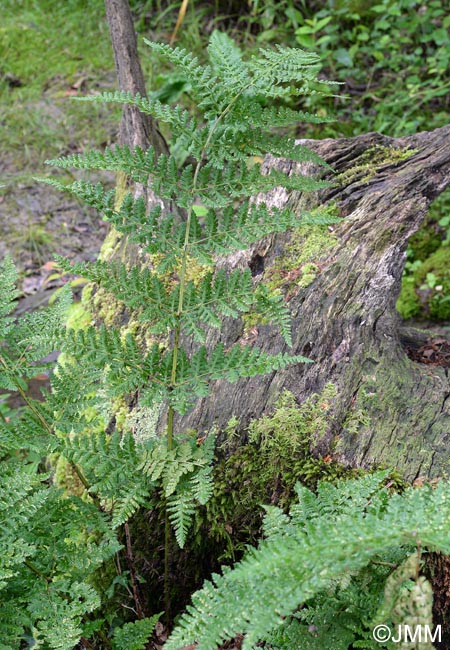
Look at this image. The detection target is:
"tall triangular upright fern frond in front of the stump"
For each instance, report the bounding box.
[39,32,338,544]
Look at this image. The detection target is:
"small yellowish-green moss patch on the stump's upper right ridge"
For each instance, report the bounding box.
[336,145,417,185]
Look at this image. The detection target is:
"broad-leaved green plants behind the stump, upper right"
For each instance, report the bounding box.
[286,0,450,136]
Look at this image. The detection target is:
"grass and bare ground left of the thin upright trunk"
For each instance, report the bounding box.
[0,0,120,312]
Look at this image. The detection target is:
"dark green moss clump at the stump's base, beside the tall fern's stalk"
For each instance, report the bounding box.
[194,384,360,561]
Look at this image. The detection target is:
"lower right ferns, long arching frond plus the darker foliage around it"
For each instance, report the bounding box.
[165,473,450,650]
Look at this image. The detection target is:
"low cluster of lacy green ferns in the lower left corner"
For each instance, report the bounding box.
[0,258,156,650]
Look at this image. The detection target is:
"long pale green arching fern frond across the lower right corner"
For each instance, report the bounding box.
[167,482,450,650]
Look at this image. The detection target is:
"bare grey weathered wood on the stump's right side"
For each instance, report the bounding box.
[173,127,450,479]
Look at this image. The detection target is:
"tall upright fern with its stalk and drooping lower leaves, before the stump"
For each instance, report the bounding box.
[21,32,340,634]
